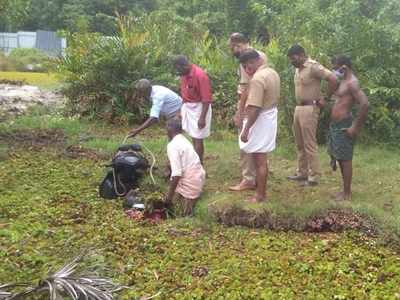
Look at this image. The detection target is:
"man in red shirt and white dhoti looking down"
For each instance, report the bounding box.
[174,55,212,164]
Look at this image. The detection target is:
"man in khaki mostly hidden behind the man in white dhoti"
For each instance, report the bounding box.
[229,32,267,191]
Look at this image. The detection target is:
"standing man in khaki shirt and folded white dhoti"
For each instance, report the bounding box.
[239,49,280,202]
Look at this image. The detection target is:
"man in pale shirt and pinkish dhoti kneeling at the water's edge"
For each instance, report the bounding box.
[164,118,206,216]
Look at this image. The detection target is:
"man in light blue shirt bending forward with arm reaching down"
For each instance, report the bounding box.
[129,79,182,137]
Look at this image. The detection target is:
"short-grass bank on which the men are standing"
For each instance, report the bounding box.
[0,114,400,241]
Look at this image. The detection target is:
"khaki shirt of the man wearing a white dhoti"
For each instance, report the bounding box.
[246,64,281,110]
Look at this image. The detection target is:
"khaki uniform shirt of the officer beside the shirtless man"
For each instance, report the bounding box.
[294,59,332,104]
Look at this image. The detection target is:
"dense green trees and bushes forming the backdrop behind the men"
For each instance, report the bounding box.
[0,0,400,143]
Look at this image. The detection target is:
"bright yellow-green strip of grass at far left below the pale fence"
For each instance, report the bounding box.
[0,72,60,90]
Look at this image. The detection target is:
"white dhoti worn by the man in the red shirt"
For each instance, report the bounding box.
[181,102,212,139]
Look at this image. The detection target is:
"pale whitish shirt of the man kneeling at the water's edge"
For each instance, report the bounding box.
[167,134,201,177]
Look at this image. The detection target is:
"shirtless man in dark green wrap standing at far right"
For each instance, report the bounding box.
[328,55,368,201]
